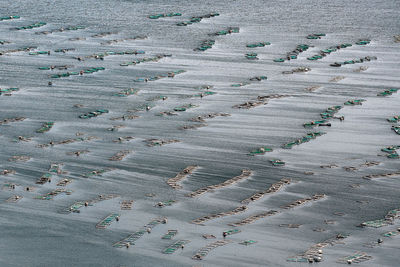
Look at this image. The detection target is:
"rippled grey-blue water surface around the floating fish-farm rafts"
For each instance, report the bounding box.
[0,0,400,266]
